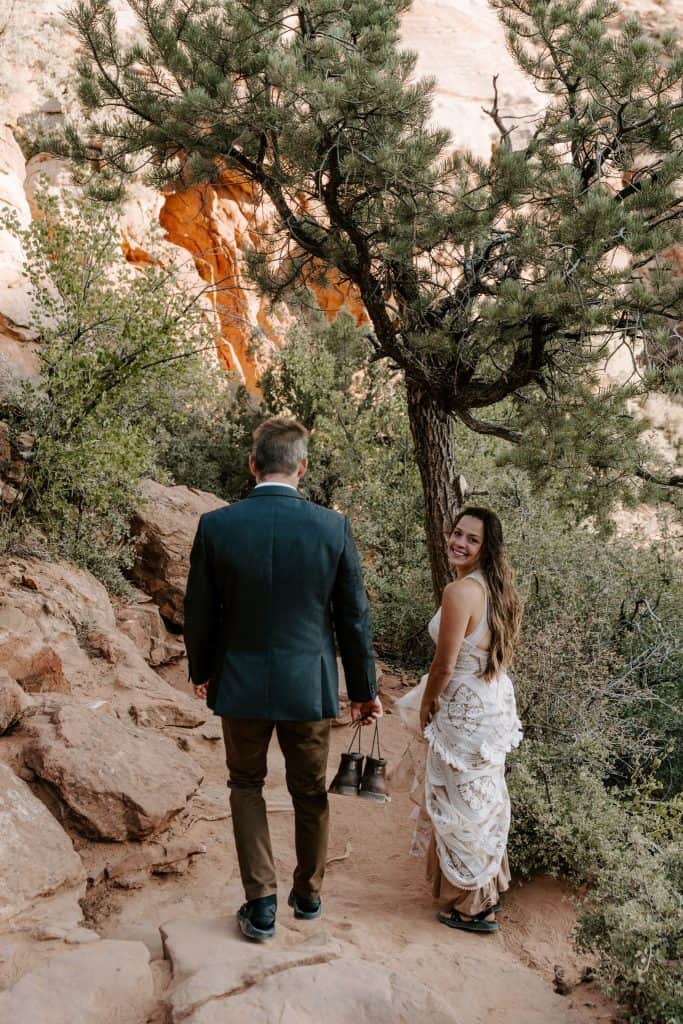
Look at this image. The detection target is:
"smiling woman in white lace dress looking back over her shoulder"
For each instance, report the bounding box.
[399,508,521,932]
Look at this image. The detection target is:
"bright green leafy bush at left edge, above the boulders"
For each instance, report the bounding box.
[5,197,223,589]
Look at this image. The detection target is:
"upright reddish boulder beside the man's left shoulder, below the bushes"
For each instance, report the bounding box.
[131,480,225,627]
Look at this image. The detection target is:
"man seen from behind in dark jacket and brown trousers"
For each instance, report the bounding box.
[184,419,382,939]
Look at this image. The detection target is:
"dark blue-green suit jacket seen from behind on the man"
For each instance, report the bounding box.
[184,483,376,722]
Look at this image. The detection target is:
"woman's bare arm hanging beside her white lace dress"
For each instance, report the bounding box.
[420,580,484,729]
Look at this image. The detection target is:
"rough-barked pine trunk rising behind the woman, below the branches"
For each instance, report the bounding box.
[405,380,463,602]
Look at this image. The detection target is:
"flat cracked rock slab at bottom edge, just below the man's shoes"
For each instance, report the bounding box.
[161,919,459,1024]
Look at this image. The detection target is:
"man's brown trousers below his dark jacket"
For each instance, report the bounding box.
[221,718,330,900]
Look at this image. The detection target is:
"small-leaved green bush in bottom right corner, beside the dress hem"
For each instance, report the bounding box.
[508,740,683,1024]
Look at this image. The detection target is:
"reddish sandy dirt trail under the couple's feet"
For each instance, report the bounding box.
[73,666,614,1024]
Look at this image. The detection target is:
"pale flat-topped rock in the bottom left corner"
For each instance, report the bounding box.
[0,939,155,1024]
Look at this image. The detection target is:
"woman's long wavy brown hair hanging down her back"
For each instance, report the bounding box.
[453,506,522,682]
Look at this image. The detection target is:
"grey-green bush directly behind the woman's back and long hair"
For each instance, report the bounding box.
[492,473,683,793]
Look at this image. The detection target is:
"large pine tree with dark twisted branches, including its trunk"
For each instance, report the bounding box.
[69,0,683,593]
